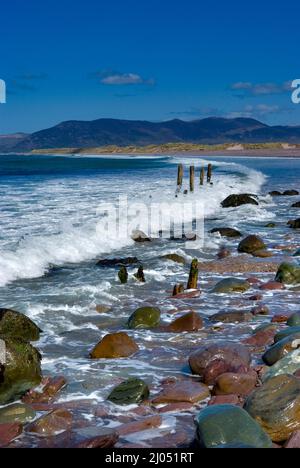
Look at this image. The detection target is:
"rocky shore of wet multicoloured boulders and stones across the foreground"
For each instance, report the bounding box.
[0,189,300,450]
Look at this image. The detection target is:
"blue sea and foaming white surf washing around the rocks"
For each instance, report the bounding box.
[0,155,300,444]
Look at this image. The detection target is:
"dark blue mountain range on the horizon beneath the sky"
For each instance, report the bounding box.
[0,117,300,152]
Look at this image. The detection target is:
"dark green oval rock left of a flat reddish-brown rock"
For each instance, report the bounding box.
[108,379,150,405]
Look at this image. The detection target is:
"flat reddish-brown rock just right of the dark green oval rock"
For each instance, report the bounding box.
[153,380,210,404]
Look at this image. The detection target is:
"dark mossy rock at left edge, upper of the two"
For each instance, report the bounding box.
[0,309,41,341]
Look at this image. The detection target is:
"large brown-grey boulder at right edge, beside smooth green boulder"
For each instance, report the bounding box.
[245,375,300,442]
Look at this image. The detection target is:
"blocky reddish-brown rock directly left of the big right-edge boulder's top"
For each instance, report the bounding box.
[213,371,257,396]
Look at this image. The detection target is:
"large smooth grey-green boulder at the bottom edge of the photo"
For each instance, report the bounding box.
[196,405,272,449]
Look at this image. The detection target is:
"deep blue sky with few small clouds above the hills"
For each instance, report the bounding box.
[0,0,300,134]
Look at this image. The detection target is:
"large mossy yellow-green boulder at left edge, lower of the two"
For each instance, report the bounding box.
[0,338,42,405]
